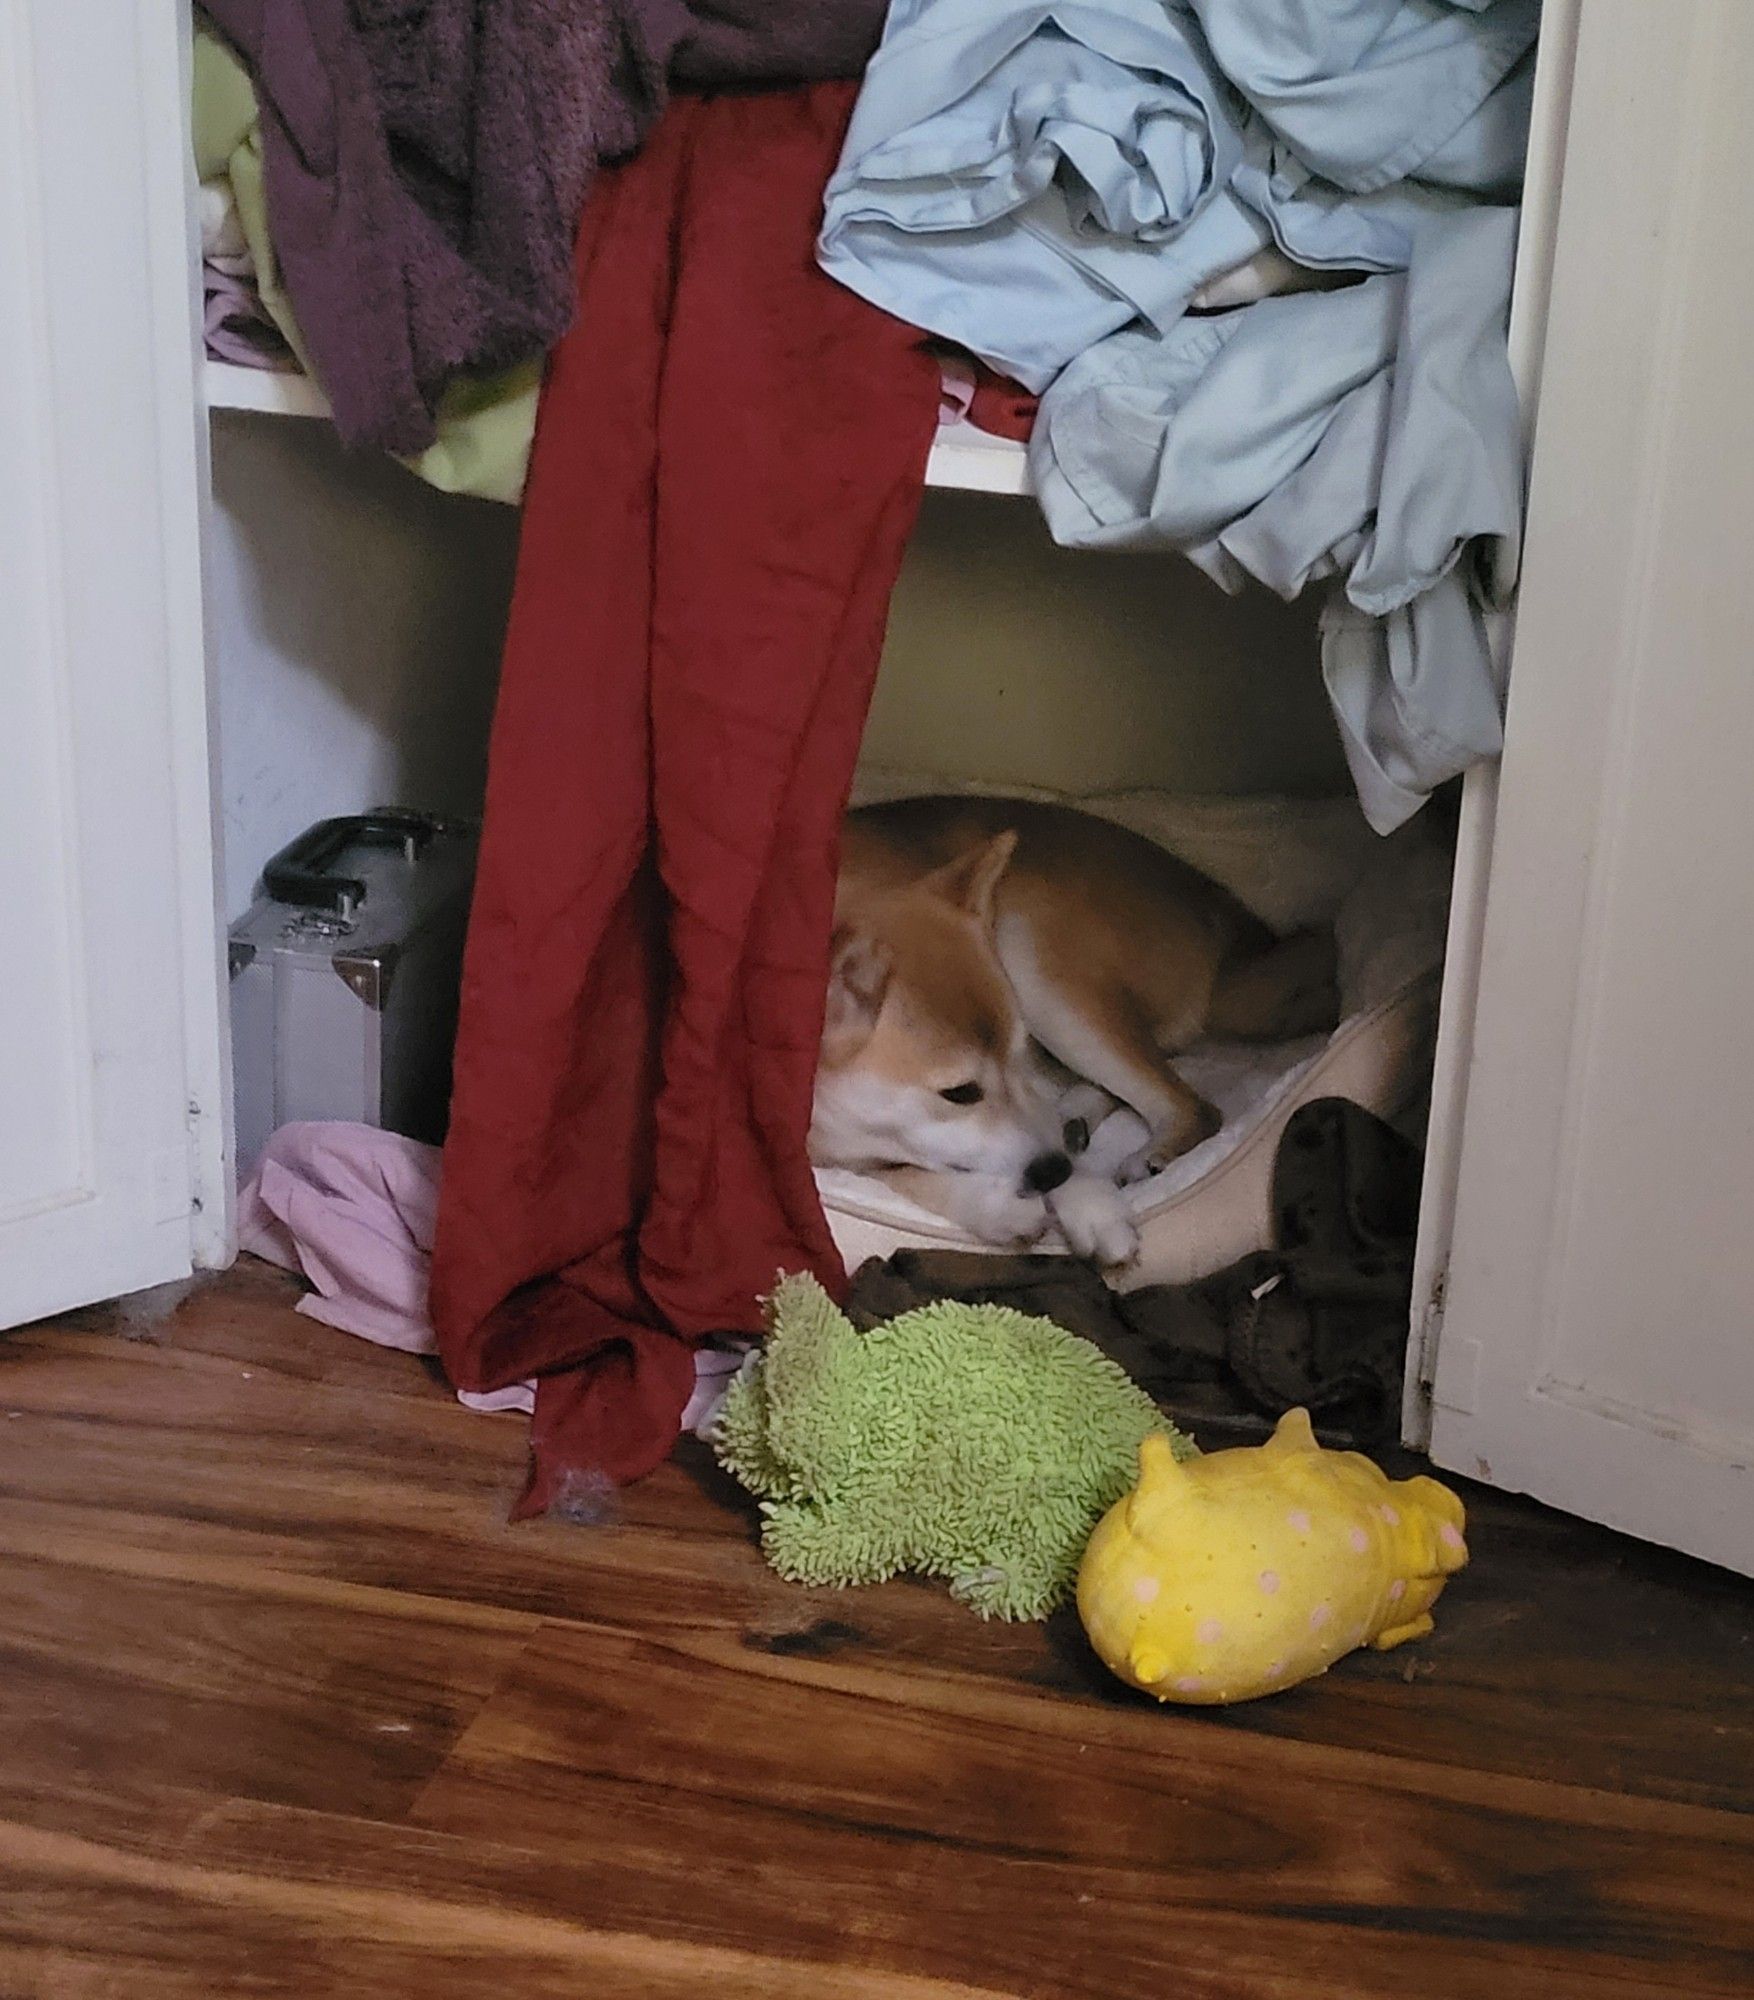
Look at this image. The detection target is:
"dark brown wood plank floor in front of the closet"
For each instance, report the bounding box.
[0,1268,1754,2000]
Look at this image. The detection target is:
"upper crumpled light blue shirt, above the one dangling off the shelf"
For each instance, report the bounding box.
[820,0,1540,374]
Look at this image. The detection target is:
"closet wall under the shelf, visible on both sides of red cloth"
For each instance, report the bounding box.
[208,434,1348,918]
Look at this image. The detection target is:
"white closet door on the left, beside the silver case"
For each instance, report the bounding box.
[0,0,226,1324]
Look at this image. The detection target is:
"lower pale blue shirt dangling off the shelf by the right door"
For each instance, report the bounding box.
[1030,208,1522,832]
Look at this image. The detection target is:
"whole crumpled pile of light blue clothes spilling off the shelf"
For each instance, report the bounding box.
[822,0,1540,830]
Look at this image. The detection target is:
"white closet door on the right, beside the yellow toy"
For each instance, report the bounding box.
[1432,0,1754,1572]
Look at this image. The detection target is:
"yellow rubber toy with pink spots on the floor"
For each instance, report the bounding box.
[1078,1410,1468,1704]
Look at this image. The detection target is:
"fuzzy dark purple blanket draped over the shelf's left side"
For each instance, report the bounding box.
[202,0,884,454]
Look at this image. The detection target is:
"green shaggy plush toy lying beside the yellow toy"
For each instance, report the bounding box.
[714,1278,1194,1618]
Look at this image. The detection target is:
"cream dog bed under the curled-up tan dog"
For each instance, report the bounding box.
[816,772,1450,1290]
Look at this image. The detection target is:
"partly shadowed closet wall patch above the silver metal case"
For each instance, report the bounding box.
[206,428,518,920]
